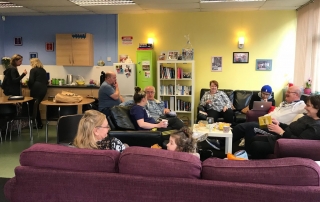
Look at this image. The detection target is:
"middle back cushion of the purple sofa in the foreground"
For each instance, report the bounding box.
[119,147,201,178]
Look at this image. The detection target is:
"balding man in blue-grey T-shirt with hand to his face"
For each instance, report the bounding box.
[99,71,123,116]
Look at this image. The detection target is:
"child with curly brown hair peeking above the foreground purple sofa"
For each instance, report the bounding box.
[167,126,200,158]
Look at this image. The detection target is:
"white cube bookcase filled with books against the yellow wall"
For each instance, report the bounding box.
[157,60,195,126]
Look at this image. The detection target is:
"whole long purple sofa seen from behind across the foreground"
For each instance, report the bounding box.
[4,143,320,202]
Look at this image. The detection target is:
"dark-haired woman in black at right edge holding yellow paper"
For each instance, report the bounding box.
[250,95,320,159]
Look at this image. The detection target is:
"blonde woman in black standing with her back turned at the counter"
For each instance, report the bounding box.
[28,58,48,129]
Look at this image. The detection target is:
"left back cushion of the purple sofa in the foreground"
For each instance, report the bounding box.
[20,143,120,173]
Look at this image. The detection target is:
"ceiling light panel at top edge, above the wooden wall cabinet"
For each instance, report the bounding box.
[69,0,135,6]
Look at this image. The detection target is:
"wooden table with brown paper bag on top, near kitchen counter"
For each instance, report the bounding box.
[41,98,95,143]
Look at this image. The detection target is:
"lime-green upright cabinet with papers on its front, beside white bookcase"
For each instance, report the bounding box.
[137,50,156,89]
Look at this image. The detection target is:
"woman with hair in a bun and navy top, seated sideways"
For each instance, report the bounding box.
[130,87,170,131]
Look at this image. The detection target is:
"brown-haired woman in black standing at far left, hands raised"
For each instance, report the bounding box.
[2,54,27,96]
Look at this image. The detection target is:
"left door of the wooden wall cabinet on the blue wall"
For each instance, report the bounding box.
[56,34,72,66]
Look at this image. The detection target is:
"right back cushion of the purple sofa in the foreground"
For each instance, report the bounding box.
[202,157,320,186]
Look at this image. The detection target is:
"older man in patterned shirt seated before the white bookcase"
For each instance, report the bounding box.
[144,86,184,130]
